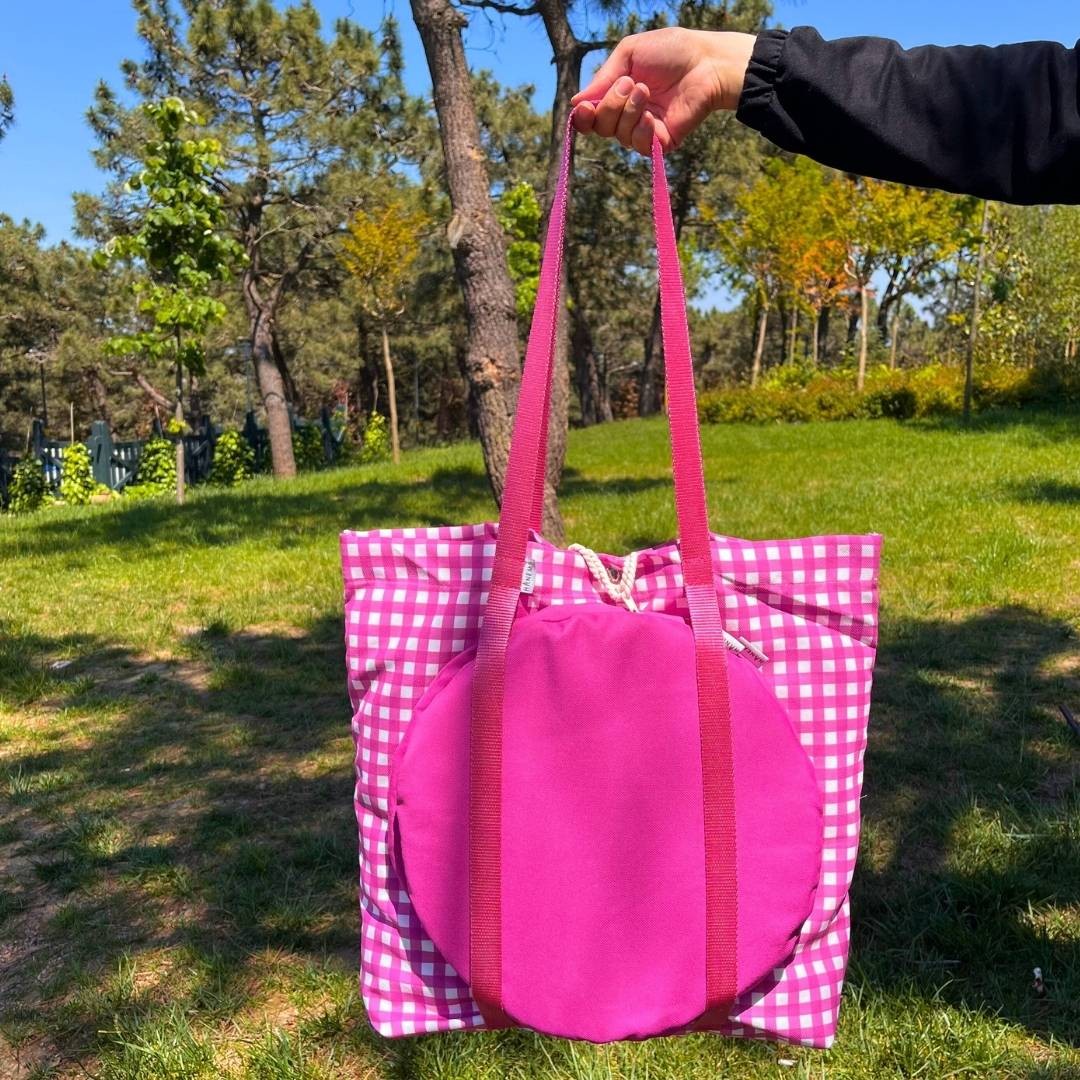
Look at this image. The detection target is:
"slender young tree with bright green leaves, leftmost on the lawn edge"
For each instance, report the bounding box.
[98,97,243,503]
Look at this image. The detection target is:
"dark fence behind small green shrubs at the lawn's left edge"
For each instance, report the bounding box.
[0,407,343,507]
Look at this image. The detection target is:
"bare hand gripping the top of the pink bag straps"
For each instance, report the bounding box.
[572,26,756,153]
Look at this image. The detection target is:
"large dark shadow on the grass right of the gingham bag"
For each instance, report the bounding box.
[852,607,1080,1044]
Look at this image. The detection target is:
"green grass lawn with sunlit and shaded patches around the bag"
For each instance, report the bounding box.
[0,415,1080,1080]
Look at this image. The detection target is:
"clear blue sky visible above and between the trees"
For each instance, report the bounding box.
[0,0,1080,240]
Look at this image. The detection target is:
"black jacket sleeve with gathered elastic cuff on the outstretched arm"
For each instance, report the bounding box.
[735,27,1080,203]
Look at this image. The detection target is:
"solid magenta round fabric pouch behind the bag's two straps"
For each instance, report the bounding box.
[389,604,822,1042]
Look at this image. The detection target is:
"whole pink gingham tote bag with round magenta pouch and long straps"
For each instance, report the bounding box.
[341,118,880,1047]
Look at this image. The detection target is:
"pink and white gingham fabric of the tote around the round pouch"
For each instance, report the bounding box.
[341,524,880,1047]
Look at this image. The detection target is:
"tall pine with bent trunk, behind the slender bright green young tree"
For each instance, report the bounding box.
[81,0,416,476]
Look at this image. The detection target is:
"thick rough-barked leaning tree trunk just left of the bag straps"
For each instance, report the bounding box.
[411,0,521,500]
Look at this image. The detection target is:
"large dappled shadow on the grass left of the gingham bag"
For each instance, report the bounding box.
[0,612,397,1075]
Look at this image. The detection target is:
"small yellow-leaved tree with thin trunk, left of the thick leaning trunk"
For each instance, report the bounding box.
[341,198,428,464]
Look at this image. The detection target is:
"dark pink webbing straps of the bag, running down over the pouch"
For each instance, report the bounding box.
[469,112,737,1027]
